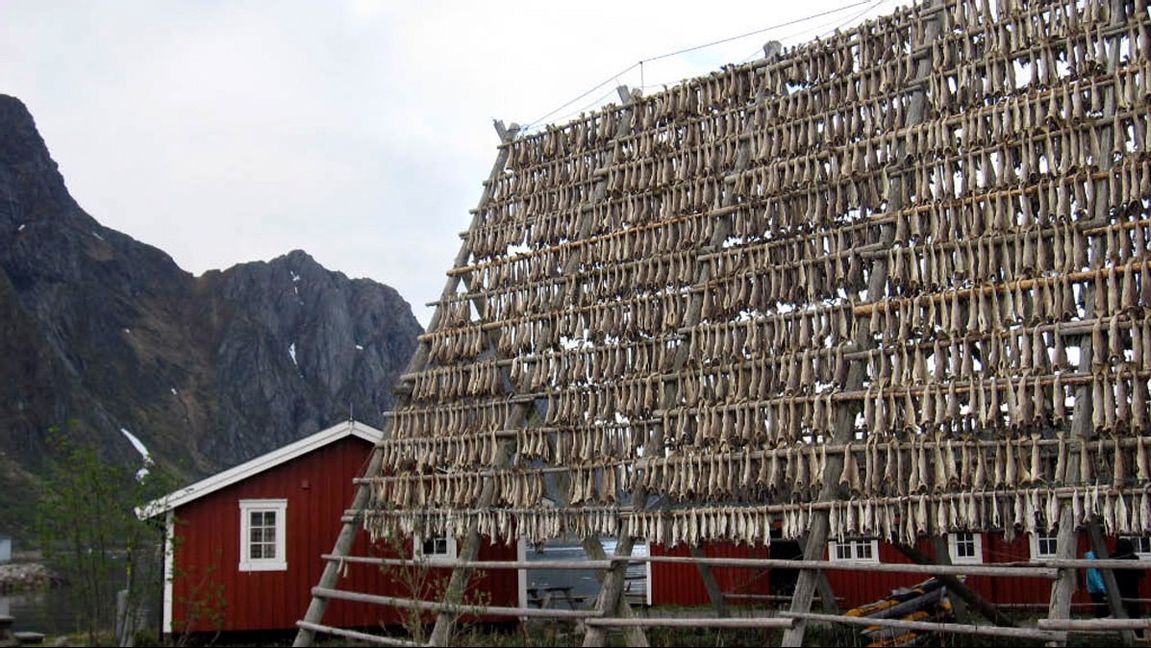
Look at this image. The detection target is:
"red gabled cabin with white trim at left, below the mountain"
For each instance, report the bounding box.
[142,421,523,634]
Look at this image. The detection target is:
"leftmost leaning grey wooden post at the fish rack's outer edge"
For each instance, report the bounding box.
[292,121,518,646]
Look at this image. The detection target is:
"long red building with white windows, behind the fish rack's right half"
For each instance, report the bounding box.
[648,533,1151,613]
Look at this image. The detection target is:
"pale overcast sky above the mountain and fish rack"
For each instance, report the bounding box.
[0,0,897,325]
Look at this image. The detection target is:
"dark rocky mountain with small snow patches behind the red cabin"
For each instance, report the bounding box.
[0,94,420,535]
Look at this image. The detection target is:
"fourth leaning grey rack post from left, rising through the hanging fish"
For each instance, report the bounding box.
[782,1,939,646]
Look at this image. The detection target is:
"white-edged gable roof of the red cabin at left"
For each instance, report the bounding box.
[136,420,383,519]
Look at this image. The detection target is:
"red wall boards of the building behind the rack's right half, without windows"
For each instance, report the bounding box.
[650,533,1151,613]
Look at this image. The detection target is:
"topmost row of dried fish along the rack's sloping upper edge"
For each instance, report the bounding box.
[511,0,1132,177]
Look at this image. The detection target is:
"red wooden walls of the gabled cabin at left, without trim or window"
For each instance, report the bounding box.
[173,436,518,633]
